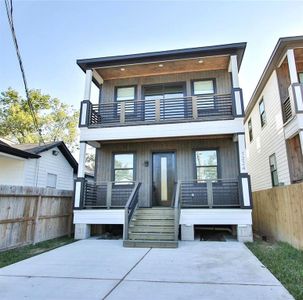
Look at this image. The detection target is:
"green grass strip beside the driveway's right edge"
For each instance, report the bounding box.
[246,241,303,300]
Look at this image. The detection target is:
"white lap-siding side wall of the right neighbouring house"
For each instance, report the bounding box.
[245,71,290,191]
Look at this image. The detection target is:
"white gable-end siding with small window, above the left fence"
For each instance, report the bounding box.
[24,148,73,190]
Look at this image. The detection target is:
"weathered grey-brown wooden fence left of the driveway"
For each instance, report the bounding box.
[0,185,73,251]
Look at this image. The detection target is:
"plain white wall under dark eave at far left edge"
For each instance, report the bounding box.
[0,156,25,185]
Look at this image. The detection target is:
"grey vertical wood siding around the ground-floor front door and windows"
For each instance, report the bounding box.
[96,136,239,206]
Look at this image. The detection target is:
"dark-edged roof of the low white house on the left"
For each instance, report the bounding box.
[0,141,78,173]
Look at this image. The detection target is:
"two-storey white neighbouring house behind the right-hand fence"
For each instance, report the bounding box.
[244,36,303,191]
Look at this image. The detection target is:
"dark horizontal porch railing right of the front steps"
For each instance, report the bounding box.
[180,179,240,208]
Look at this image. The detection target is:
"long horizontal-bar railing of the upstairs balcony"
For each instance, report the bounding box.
[87,94,235,127]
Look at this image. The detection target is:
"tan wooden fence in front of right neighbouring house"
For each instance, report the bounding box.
[253,183,303,250]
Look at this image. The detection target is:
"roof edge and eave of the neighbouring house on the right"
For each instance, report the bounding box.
[244,35,303,122]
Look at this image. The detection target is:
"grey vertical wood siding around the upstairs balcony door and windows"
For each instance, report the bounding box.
[101,70,231,103]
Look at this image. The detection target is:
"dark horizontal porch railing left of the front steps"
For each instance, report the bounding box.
[83,181,135,208]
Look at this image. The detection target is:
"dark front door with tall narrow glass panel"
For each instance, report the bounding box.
[152,152,176,206]
